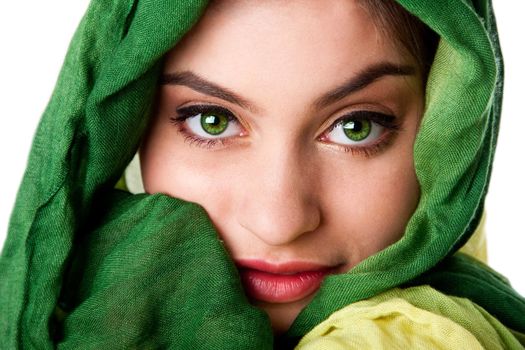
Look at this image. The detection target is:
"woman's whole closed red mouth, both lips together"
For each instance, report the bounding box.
[236,260,333,303]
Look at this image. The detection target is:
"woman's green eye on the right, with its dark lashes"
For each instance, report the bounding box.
[321,111,398,148]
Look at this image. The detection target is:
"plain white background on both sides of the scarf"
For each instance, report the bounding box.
[0,0,525,295]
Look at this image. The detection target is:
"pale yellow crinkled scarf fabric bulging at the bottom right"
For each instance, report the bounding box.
[297,286,524,350]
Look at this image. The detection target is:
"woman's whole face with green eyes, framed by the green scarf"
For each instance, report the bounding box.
[141,0,424,332]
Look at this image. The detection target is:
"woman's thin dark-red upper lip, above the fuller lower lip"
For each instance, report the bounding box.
[235,259,335,275]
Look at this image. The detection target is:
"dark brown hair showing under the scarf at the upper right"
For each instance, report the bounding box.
[358,0,439,78]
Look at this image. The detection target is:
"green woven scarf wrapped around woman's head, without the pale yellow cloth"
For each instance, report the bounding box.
[0,0,525,349]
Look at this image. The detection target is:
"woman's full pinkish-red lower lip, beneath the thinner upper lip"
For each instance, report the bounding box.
[239,268,328,303]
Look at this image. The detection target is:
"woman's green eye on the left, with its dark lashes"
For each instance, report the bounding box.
[175,105,243,139]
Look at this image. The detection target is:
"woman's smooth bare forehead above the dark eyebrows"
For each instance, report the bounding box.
[165,0,411,111]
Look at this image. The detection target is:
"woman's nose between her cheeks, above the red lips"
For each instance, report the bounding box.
[236,147,321,246]
